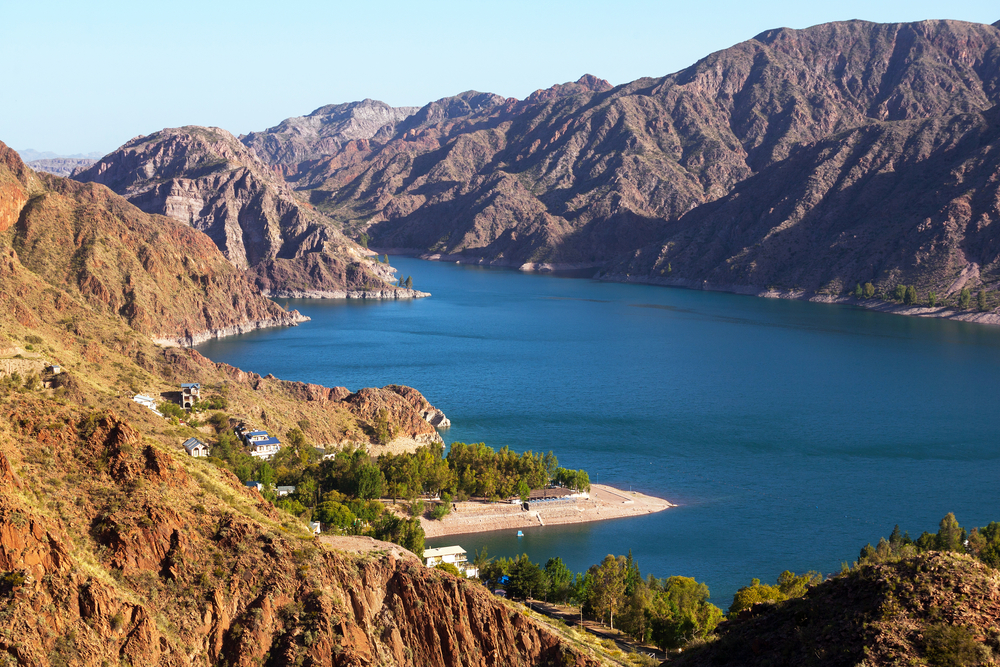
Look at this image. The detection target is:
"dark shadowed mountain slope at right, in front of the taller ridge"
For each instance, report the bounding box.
[611,107,1000,297]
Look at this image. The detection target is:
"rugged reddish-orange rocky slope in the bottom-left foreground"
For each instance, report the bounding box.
[0,406,598,667]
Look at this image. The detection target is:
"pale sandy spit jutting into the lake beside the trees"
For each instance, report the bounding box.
[420,484,674,537]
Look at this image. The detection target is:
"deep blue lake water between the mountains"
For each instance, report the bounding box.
[198,257,1000,607]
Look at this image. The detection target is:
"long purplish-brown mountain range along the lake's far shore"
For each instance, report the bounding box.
[80,21,1000,310]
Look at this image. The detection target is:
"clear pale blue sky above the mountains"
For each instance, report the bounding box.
[0,0,1000,154]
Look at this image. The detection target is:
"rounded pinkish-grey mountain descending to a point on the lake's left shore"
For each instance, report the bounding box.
[73,127,412,296]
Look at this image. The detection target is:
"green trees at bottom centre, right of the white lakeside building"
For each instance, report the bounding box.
[476,551,722,651]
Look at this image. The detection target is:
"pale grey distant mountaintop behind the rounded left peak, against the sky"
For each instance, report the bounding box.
[240,100,419,166]
